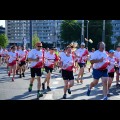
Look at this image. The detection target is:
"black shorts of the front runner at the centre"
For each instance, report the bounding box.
[62,69,74,80]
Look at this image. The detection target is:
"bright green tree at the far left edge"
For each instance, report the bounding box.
[0,34,9,48]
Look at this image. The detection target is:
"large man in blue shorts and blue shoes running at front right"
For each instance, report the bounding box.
[87,42,109,100]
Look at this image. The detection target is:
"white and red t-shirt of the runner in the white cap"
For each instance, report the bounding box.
[75,48,88,63]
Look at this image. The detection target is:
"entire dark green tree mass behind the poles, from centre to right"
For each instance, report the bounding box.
[60,20,113,50]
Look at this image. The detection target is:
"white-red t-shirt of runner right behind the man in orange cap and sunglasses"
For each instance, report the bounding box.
[45,52,56,68]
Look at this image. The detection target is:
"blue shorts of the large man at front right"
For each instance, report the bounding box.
[92,68,108,80]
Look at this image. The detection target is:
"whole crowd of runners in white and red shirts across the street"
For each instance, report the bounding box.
[0,42,120,100]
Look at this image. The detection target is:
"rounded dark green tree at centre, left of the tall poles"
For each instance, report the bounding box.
[60,20,81,44]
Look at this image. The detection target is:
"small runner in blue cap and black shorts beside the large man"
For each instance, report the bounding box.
[107,50,117,96]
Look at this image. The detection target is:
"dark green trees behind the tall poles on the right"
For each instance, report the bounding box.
[85,20,113,50]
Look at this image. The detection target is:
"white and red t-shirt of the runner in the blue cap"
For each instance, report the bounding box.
[107,56,117,73]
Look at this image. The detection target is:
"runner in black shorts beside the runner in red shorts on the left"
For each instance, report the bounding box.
[18,46,27,78]
